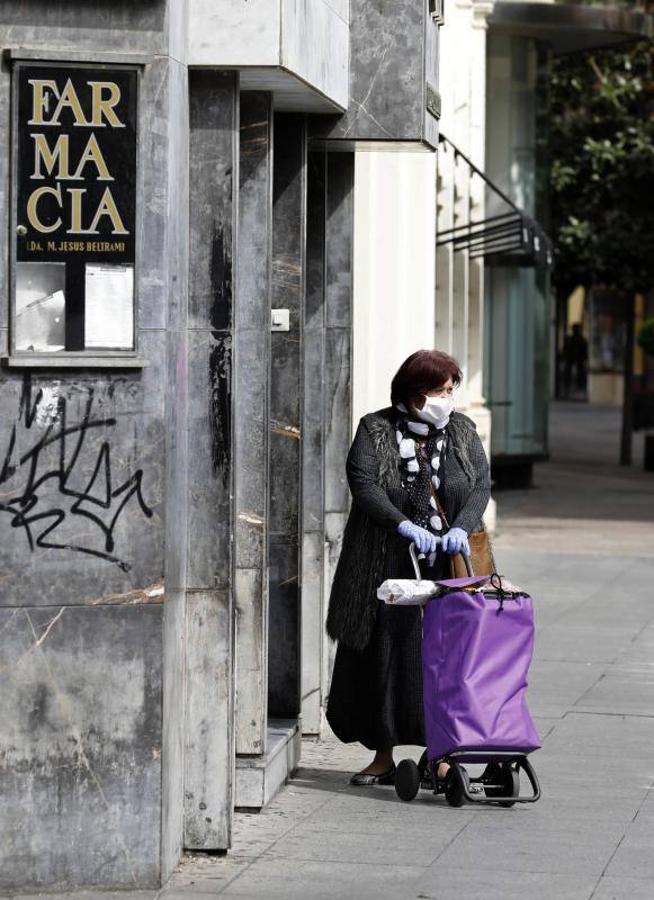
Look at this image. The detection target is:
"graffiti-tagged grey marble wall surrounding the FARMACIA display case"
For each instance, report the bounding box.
[0,2,178,893]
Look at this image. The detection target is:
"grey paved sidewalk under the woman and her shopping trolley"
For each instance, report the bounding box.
[15,404,654,900]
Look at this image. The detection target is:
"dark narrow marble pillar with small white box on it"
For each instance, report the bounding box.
[268,113,307,718]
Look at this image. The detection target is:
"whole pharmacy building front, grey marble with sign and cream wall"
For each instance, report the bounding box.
[0,0,446,892]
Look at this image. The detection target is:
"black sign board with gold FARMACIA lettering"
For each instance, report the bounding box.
[16,64,137,264]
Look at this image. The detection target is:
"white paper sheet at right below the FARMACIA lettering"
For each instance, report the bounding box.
[84,263,134,350]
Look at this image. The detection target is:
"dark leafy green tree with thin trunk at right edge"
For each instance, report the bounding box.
[548,31,654,463]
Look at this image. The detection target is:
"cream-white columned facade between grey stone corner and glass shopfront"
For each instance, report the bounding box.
[436,0,494,474]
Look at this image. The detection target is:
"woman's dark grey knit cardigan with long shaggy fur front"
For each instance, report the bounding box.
[327,407,490,650]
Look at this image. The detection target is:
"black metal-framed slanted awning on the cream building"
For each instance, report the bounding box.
[436,132,553,266]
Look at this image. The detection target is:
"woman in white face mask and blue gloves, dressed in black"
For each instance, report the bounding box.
[327,350,490,785]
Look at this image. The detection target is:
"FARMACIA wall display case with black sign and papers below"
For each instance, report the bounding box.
[9,60,143,364]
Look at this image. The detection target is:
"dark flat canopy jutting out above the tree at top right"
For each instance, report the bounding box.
[488,0,654,54]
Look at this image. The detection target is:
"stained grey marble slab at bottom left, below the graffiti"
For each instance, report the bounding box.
[0,595,162,893]
